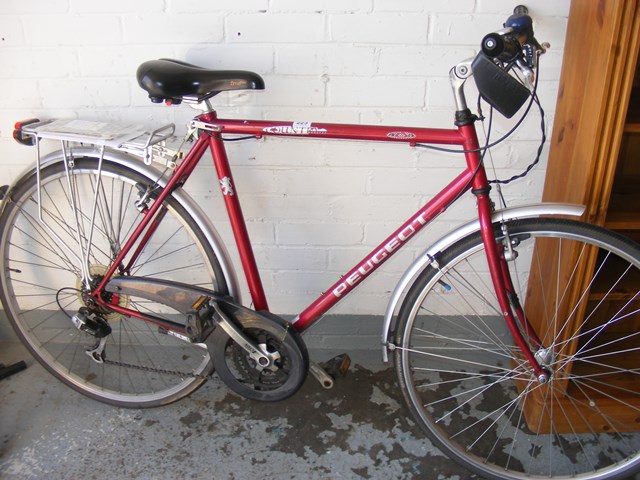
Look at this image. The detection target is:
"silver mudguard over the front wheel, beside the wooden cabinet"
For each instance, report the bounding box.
[381,203,585,363]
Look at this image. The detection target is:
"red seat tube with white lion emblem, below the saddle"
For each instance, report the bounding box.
[208,133,269,311]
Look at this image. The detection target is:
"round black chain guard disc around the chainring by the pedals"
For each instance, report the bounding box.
[206,302,309,402]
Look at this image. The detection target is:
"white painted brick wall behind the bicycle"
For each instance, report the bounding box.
[0,0,569,315]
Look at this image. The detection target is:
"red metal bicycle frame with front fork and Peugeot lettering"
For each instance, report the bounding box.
[93,112,544,375]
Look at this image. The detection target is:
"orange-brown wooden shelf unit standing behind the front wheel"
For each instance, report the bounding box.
[525,0,640,432]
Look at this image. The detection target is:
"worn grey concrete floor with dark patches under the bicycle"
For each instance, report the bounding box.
[0,342,473,480]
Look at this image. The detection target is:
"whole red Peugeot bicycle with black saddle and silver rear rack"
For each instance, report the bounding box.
[0,7,640,479]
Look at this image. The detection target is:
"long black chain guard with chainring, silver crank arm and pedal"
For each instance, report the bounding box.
[105,276,309,402]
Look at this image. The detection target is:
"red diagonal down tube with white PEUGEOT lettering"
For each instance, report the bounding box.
[293,169,473,332]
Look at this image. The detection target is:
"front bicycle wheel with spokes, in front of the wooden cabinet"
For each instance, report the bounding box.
[395,219,640,479]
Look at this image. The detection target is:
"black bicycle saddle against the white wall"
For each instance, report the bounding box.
[136,58,264,103]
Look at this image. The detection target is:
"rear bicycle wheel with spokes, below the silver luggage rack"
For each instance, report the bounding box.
[0,157,227,408]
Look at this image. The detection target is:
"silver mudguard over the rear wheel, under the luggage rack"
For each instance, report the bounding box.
[7,147,241,303]
